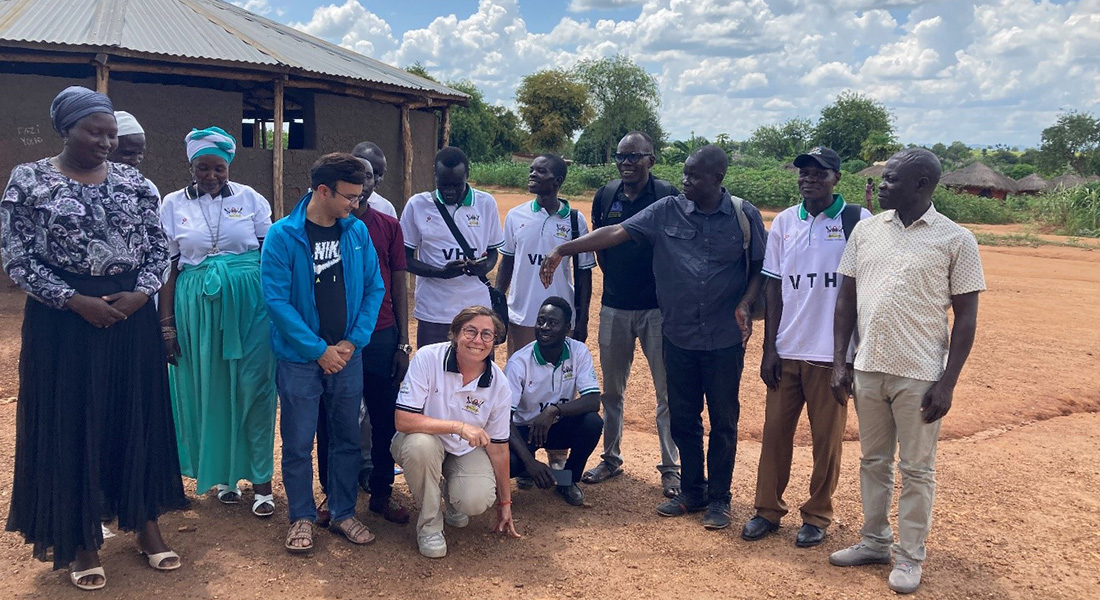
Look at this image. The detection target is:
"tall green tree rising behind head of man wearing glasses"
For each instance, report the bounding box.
[573,55,664,163]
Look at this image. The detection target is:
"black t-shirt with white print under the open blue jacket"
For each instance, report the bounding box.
[306,219,348,346]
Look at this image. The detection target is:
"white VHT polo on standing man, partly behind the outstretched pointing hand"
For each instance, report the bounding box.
[501,200,596,327]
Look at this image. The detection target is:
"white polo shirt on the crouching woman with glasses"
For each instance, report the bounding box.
[397,341,512,456]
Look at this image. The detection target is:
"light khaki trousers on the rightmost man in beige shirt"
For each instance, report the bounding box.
[855,371,943,564]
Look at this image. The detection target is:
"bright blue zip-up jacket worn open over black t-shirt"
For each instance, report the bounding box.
[260,192,385,362]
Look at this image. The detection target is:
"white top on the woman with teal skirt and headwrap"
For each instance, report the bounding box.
[161,182,272,265]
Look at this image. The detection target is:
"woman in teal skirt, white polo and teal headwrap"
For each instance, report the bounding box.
[160,127,275,516]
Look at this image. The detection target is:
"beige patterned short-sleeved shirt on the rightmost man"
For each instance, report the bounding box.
[837,206,986,381]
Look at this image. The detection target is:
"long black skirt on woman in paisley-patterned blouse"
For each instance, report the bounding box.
[7,272,187,569]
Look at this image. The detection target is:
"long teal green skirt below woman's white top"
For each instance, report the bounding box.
[168,251,275,493]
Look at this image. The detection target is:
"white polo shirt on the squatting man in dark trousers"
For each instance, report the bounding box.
[504,338,600,425]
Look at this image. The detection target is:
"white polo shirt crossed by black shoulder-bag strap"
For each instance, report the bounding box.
[402,187,504,324]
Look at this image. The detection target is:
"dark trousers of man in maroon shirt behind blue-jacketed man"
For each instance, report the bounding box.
[317,325,400,502]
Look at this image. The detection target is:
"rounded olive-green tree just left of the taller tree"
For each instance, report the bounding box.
[516,69,594,152]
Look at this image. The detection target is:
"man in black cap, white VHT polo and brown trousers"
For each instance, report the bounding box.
[741,146,871,547]
